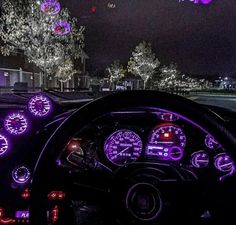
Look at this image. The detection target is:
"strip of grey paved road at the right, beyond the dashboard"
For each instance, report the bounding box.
[189,95,236,110]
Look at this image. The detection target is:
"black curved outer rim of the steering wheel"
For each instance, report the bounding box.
[30,91,236,225]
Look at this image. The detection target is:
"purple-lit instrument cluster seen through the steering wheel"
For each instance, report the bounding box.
[60,110,235,178]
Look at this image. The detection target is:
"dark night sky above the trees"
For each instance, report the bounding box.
[60,0,236,76]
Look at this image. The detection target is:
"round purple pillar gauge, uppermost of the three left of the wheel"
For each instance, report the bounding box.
[28,95,52,117]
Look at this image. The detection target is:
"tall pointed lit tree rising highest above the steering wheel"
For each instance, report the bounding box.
[128,42,160,89]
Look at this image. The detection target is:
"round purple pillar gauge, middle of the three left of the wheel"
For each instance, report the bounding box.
[4,113,28,135]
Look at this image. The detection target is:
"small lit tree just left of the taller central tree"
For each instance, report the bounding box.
[106,60,126,90]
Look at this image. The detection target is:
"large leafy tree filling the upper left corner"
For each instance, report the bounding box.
[0,0,84,87]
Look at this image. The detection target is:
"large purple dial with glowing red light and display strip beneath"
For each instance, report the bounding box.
[146,123,186,161]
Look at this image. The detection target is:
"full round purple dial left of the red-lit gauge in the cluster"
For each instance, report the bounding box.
[104,130,143,166]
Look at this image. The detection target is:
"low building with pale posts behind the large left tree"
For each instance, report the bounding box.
[0,52,89,92]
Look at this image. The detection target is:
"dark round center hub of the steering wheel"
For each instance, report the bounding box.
[126,183,162,221]
